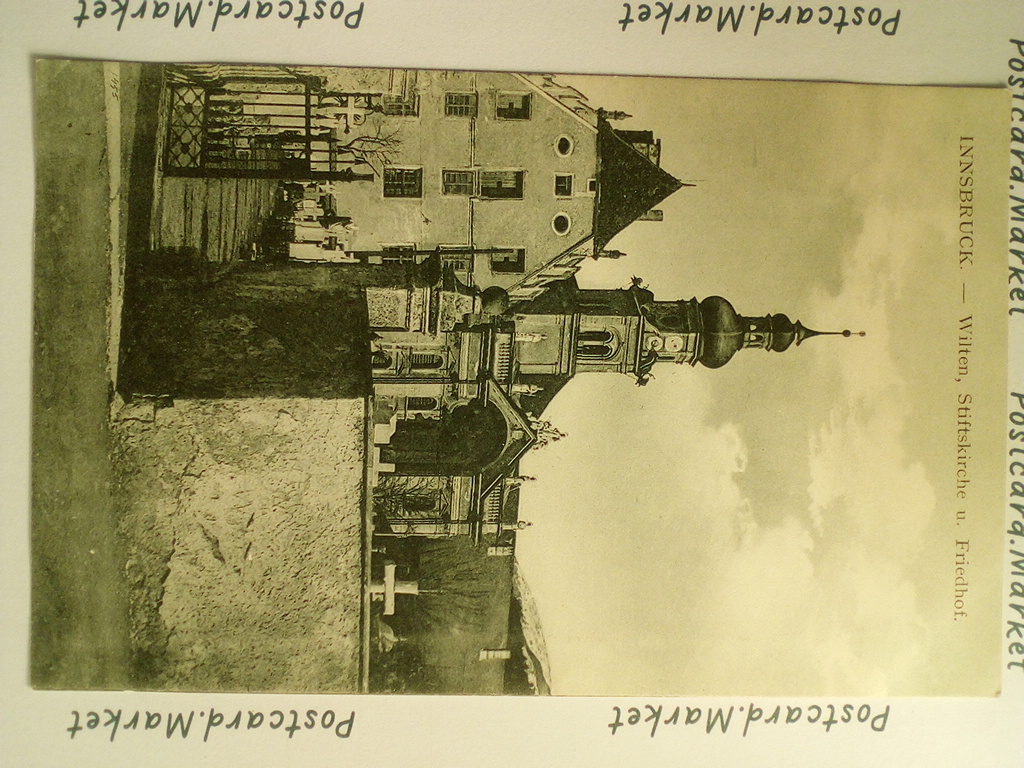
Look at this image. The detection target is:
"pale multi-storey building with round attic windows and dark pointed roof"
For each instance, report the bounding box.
[288,70,682,300]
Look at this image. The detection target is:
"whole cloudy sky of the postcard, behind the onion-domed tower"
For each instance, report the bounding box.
[517,78,1005,694]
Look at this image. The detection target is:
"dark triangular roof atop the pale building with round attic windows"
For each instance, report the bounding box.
[594,117,684,253]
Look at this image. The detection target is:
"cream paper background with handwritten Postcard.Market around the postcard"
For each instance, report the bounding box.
[0,0,1024,766]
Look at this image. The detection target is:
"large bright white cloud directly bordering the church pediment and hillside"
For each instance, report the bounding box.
[517,367,753,694]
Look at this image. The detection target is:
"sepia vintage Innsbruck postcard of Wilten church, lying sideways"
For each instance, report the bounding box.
[31,59,1007,695]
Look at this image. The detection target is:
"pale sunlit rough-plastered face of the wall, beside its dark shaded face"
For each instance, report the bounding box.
[114,398,365,691]
